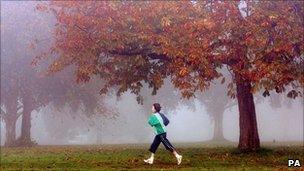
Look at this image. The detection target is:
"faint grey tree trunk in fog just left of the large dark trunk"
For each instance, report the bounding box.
[212,111,226,141]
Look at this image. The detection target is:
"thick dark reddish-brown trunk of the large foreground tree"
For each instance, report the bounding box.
[235,74,260,151]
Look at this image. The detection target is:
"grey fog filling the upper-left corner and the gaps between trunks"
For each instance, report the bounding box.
[1,1,304,145]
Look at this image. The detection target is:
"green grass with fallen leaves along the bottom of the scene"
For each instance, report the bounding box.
[1,143,304,170]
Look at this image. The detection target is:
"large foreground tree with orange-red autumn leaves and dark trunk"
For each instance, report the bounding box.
[36,0,304,151]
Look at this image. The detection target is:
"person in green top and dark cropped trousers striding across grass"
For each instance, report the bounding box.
[144,103,182,165]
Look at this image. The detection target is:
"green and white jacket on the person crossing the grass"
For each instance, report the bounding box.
[148,113,166,135]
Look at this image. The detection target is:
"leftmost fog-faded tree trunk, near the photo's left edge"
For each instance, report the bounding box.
[4,116,17,146]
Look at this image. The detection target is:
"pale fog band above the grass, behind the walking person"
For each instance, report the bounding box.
[1,89,303,145]
